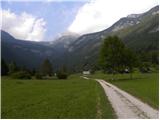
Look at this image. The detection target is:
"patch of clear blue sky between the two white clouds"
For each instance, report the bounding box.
[2,1,85,40]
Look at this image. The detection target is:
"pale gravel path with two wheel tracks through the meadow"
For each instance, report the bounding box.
[84,77,158,119]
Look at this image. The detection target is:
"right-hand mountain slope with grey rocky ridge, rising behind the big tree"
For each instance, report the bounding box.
[65,6,159,70]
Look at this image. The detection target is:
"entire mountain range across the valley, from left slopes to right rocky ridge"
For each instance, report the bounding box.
[1,6,159,71]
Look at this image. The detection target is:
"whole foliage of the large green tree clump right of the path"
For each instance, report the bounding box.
[99,36,136,73]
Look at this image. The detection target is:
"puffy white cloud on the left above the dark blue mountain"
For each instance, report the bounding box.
[1,10,46,41]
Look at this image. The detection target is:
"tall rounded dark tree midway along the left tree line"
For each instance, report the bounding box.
[40,59,53,76]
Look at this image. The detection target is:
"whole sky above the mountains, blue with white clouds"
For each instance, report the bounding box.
[0,0,158,41]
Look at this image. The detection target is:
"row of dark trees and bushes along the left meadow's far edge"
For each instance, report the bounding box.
[1,58,68,79]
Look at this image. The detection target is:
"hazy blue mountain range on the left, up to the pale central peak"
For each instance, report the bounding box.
[1,30,77,70]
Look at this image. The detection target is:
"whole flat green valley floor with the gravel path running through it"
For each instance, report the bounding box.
[1,72,159,119]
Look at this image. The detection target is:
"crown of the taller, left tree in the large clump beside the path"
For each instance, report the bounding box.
[99,36,125,73]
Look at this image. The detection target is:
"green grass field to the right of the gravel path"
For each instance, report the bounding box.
[89,72,159,109]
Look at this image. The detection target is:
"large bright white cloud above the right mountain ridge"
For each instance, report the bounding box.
[68,0,158,34]
